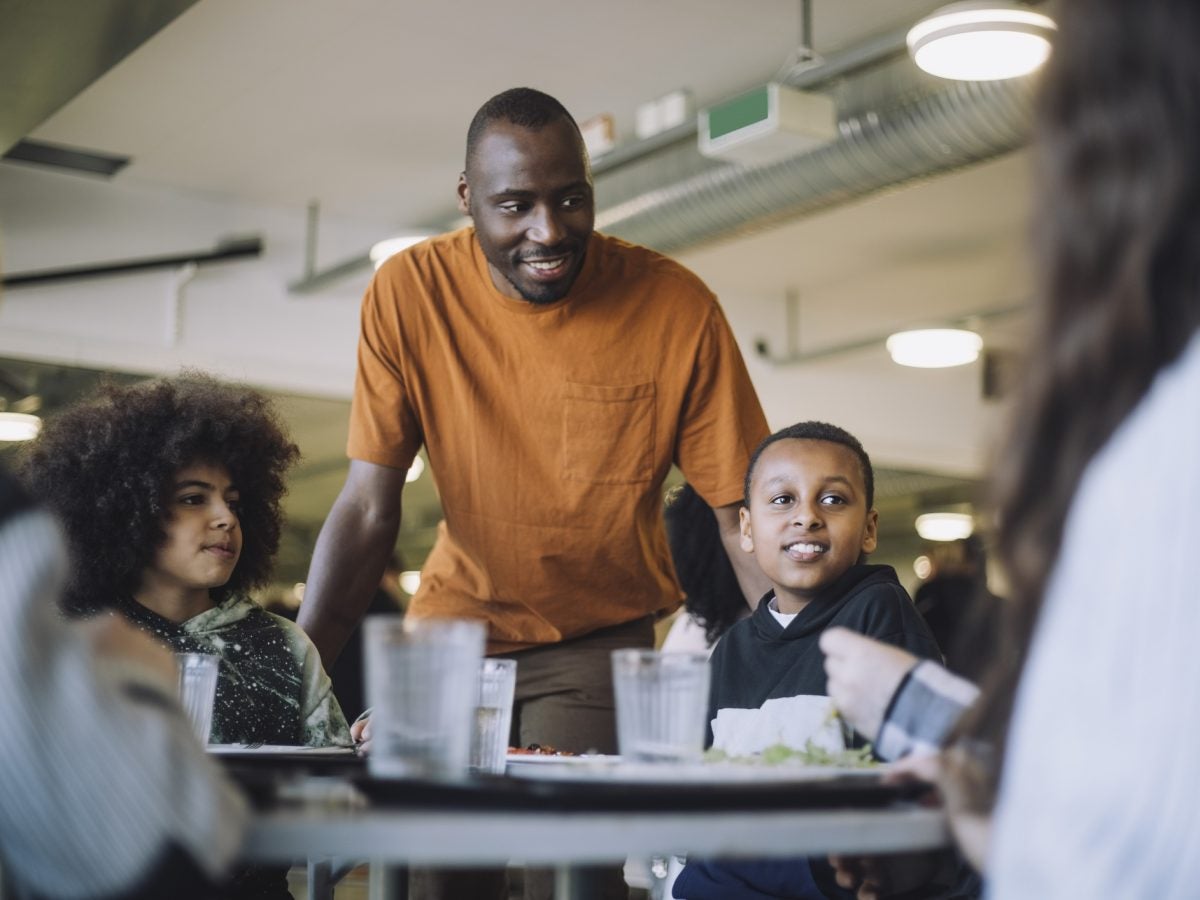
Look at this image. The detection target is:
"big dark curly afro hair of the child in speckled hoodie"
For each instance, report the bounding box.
[20,373,300,613]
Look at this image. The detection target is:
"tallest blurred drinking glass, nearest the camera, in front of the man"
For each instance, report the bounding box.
[364,616,487,780]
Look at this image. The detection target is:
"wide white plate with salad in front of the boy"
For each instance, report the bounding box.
[509,756,887,785]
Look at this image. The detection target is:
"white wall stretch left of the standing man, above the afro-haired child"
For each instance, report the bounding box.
[0,164,388,397]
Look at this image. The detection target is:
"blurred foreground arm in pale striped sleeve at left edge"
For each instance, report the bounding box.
[0,504,246,900]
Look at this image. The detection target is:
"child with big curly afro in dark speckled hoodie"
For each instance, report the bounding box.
[20,374,350,746]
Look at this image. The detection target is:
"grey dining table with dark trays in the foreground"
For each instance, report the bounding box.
[216,752,950,900]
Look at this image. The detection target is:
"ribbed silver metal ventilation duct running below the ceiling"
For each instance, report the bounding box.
[596,56,1032,252]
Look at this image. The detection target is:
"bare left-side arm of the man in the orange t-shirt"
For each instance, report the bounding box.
[296,460,406,671]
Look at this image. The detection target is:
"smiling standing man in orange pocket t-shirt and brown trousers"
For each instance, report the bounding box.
[300,88,767,896]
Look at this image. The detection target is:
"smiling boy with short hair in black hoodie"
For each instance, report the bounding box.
[673,422,977,900]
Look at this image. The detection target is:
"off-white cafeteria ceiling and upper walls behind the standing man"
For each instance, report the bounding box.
[0,0,1028,578]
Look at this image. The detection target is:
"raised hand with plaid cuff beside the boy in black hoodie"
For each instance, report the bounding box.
[820,628,917,740]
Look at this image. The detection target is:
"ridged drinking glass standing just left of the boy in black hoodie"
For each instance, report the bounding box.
[612,649,709,762]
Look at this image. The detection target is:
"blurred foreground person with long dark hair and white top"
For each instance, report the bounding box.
[830,0,1200,900]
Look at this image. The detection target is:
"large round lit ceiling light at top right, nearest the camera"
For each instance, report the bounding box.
[908,0,1056,82]
